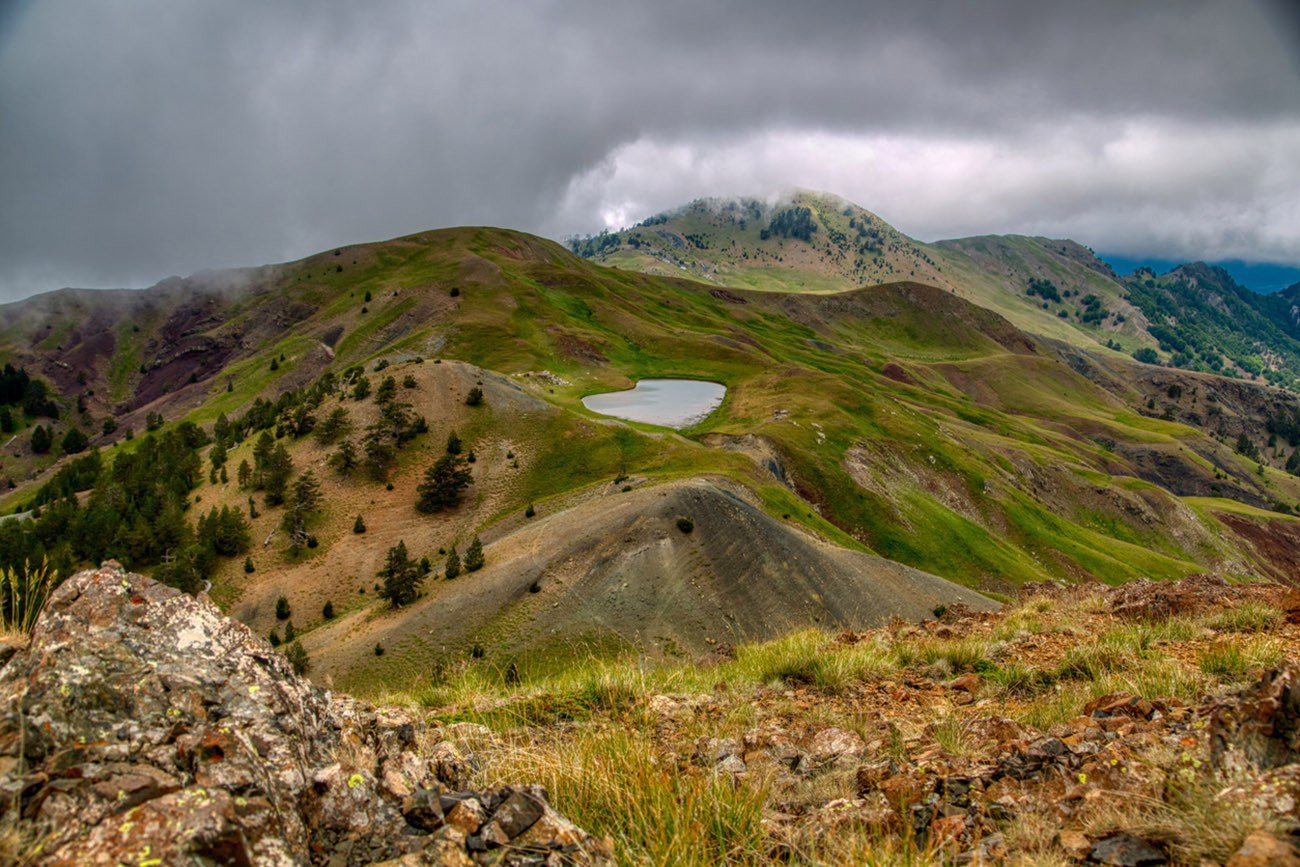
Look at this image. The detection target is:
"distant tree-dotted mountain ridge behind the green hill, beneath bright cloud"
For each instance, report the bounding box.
[572,191,1300,386]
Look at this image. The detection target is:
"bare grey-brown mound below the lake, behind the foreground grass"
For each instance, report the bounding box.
[304,478,995,684]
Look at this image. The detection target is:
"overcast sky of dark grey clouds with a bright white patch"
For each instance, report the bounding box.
[0,0,1300,299]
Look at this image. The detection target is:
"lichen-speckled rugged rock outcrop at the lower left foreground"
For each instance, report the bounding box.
[0,562,610,867]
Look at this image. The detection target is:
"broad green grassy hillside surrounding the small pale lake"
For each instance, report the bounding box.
[0,223,1300,686]
